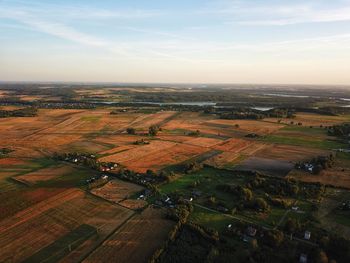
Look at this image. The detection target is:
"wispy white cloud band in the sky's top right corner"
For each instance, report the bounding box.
[199,1,350,26]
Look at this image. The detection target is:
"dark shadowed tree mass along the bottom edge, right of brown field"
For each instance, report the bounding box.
[157,222,350,263]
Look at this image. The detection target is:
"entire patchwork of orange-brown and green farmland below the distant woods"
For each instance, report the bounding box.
[0,87,350,262]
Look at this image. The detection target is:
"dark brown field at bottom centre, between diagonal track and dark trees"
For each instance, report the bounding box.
[83,208,174,263]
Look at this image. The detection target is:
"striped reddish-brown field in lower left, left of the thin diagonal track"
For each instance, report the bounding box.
[0,189,132,262]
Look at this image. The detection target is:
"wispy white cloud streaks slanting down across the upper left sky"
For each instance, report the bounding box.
[0,1,197,61]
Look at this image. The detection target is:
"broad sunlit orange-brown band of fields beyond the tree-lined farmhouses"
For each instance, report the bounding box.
[0,109,342,172]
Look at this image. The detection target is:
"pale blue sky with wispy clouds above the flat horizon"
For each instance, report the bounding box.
[0,0,350,85]
